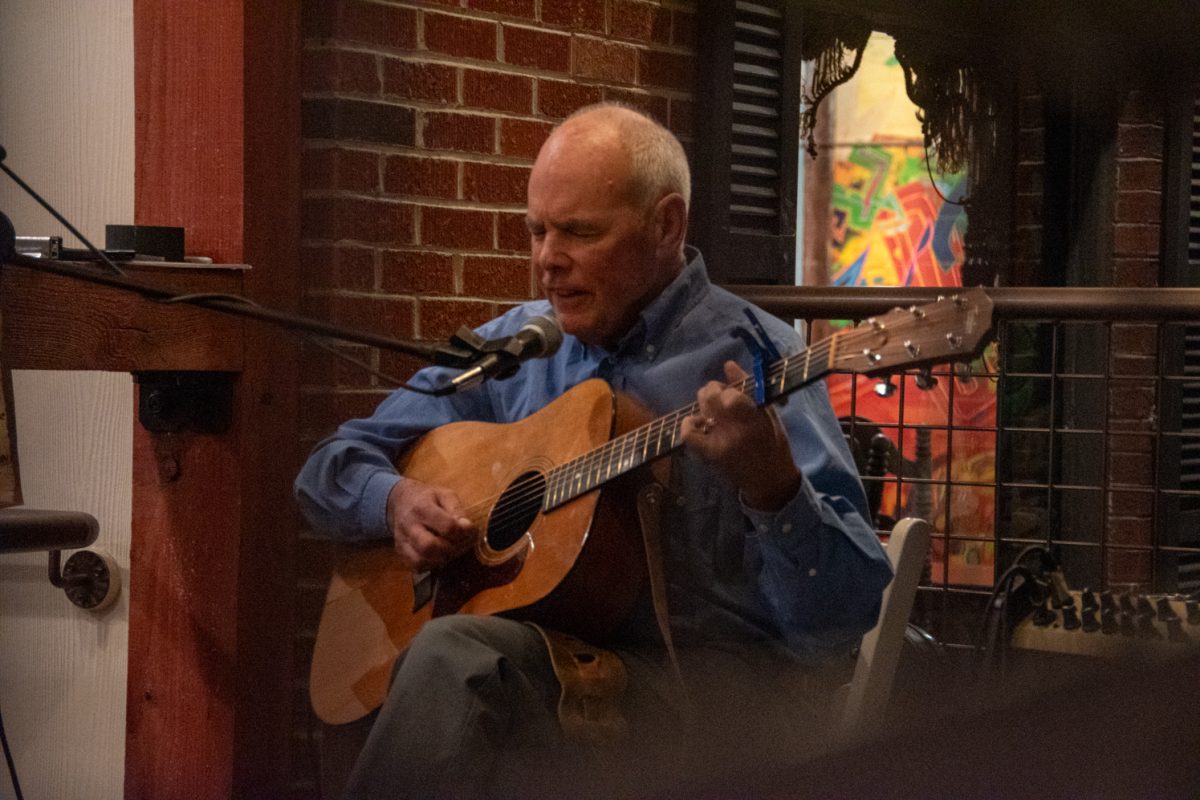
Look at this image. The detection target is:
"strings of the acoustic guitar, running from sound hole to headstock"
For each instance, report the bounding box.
[468,303,960,542]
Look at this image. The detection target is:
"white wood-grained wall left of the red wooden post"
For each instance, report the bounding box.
[0,0,133,800]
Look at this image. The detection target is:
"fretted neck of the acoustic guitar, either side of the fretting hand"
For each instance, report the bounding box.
[542,335,838,511]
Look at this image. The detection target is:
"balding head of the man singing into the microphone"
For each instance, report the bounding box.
[526,106,689,347]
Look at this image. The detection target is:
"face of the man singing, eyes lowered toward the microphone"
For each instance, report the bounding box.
[526,124,673,347]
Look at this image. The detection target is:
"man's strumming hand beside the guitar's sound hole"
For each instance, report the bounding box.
[388,477,478,572]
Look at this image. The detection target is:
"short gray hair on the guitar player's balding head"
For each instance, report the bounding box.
[560,102,691,209]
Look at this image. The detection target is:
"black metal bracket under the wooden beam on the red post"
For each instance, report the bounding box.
[133,372,236,433]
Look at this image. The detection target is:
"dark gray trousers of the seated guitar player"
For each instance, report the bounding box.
[333,615,821,800]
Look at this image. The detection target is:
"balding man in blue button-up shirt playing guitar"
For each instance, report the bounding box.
[296,104,890,798]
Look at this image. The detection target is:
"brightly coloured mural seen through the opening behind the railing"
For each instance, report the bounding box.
[827,34,996,585]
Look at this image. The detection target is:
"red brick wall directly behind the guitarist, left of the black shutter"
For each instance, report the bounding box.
[294,0,696,796]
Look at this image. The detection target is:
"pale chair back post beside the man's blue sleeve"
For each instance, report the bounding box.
[836,517,931,741]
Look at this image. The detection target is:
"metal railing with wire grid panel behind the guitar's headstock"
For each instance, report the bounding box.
[730,287,1200,644]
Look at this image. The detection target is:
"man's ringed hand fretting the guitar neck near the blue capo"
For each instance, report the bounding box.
[680,361,802,511]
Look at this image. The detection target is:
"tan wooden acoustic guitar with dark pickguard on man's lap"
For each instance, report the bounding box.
[310,289,991,723]
